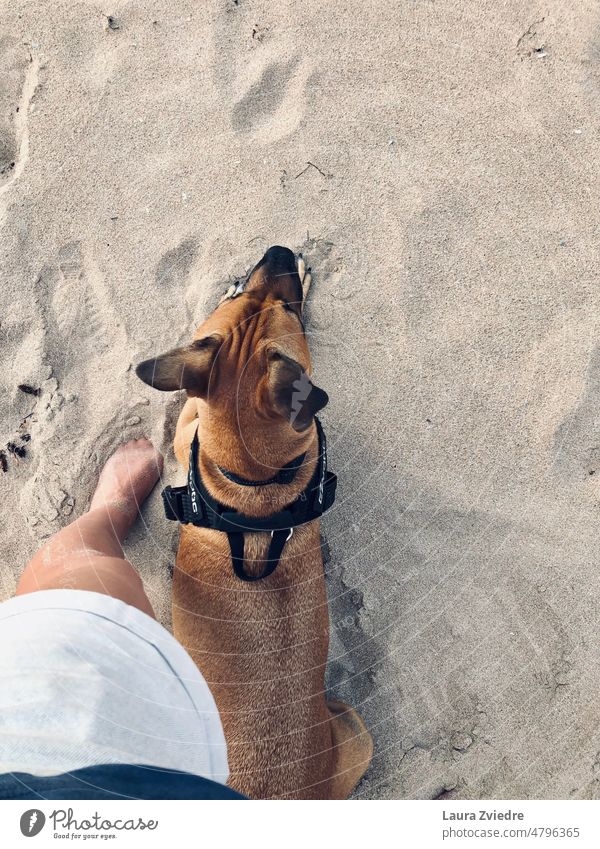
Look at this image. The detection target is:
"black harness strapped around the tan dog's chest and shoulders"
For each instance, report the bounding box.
[162,417,337,581]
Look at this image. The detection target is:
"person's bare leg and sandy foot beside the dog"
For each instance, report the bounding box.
[17,439,163,616]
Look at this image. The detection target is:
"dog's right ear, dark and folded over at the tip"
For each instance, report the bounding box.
[266,347,329,432]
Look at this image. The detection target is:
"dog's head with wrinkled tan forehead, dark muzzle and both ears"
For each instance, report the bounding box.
[136,247,328,436]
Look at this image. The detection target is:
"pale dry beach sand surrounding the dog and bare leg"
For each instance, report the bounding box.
[0,0,600,798]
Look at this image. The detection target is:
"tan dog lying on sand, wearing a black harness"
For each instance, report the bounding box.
[137,247,372,799]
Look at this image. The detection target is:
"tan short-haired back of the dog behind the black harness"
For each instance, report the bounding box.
[173,525,333,799]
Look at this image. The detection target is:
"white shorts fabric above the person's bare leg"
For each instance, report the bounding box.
[0,590,229,783]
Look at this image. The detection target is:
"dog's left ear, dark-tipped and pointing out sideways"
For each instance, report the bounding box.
[135,333,223,398]
